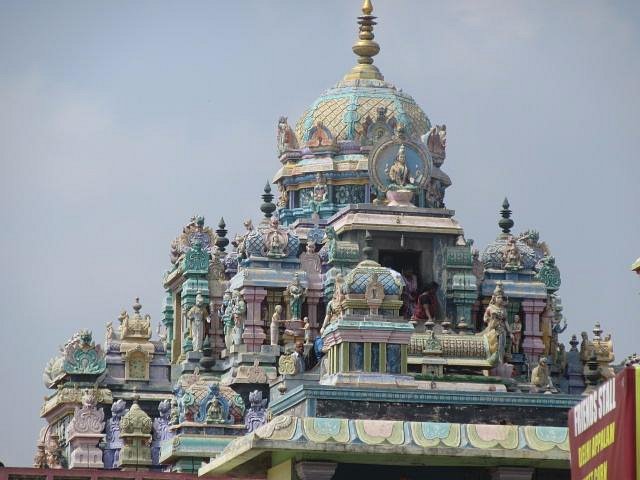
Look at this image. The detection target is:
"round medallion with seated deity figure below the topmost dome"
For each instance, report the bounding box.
[369,137,432,192]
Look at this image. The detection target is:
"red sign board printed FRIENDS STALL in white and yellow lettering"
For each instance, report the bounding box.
[569,367,640,480]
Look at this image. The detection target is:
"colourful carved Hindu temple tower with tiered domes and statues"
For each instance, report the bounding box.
[26,0,614,480]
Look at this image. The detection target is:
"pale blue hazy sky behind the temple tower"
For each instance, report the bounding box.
[0,0,640,465]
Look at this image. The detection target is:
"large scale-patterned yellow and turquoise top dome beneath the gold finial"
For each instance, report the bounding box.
[295,79,431,143]
